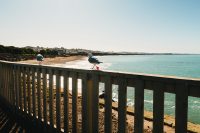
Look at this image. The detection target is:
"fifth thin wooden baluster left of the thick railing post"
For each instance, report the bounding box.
[42,69,47,124]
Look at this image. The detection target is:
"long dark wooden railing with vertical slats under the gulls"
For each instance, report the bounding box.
[0,61,200,133]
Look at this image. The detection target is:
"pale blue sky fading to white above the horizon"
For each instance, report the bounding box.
[0,0,200,53]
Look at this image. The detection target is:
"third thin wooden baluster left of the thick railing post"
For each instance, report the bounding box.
[56,71,61,132]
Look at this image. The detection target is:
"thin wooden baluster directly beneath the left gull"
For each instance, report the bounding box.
[37,68,41,120]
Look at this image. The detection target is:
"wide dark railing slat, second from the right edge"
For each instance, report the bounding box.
[153,83,164,133]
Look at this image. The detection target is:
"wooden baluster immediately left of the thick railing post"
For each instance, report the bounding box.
[72,72,78,133]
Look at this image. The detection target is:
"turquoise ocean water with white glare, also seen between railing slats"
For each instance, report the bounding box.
[61,55,200,124]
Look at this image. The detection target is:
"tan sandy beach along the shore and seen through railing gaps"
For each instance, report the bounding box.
[21,56,200,133]
